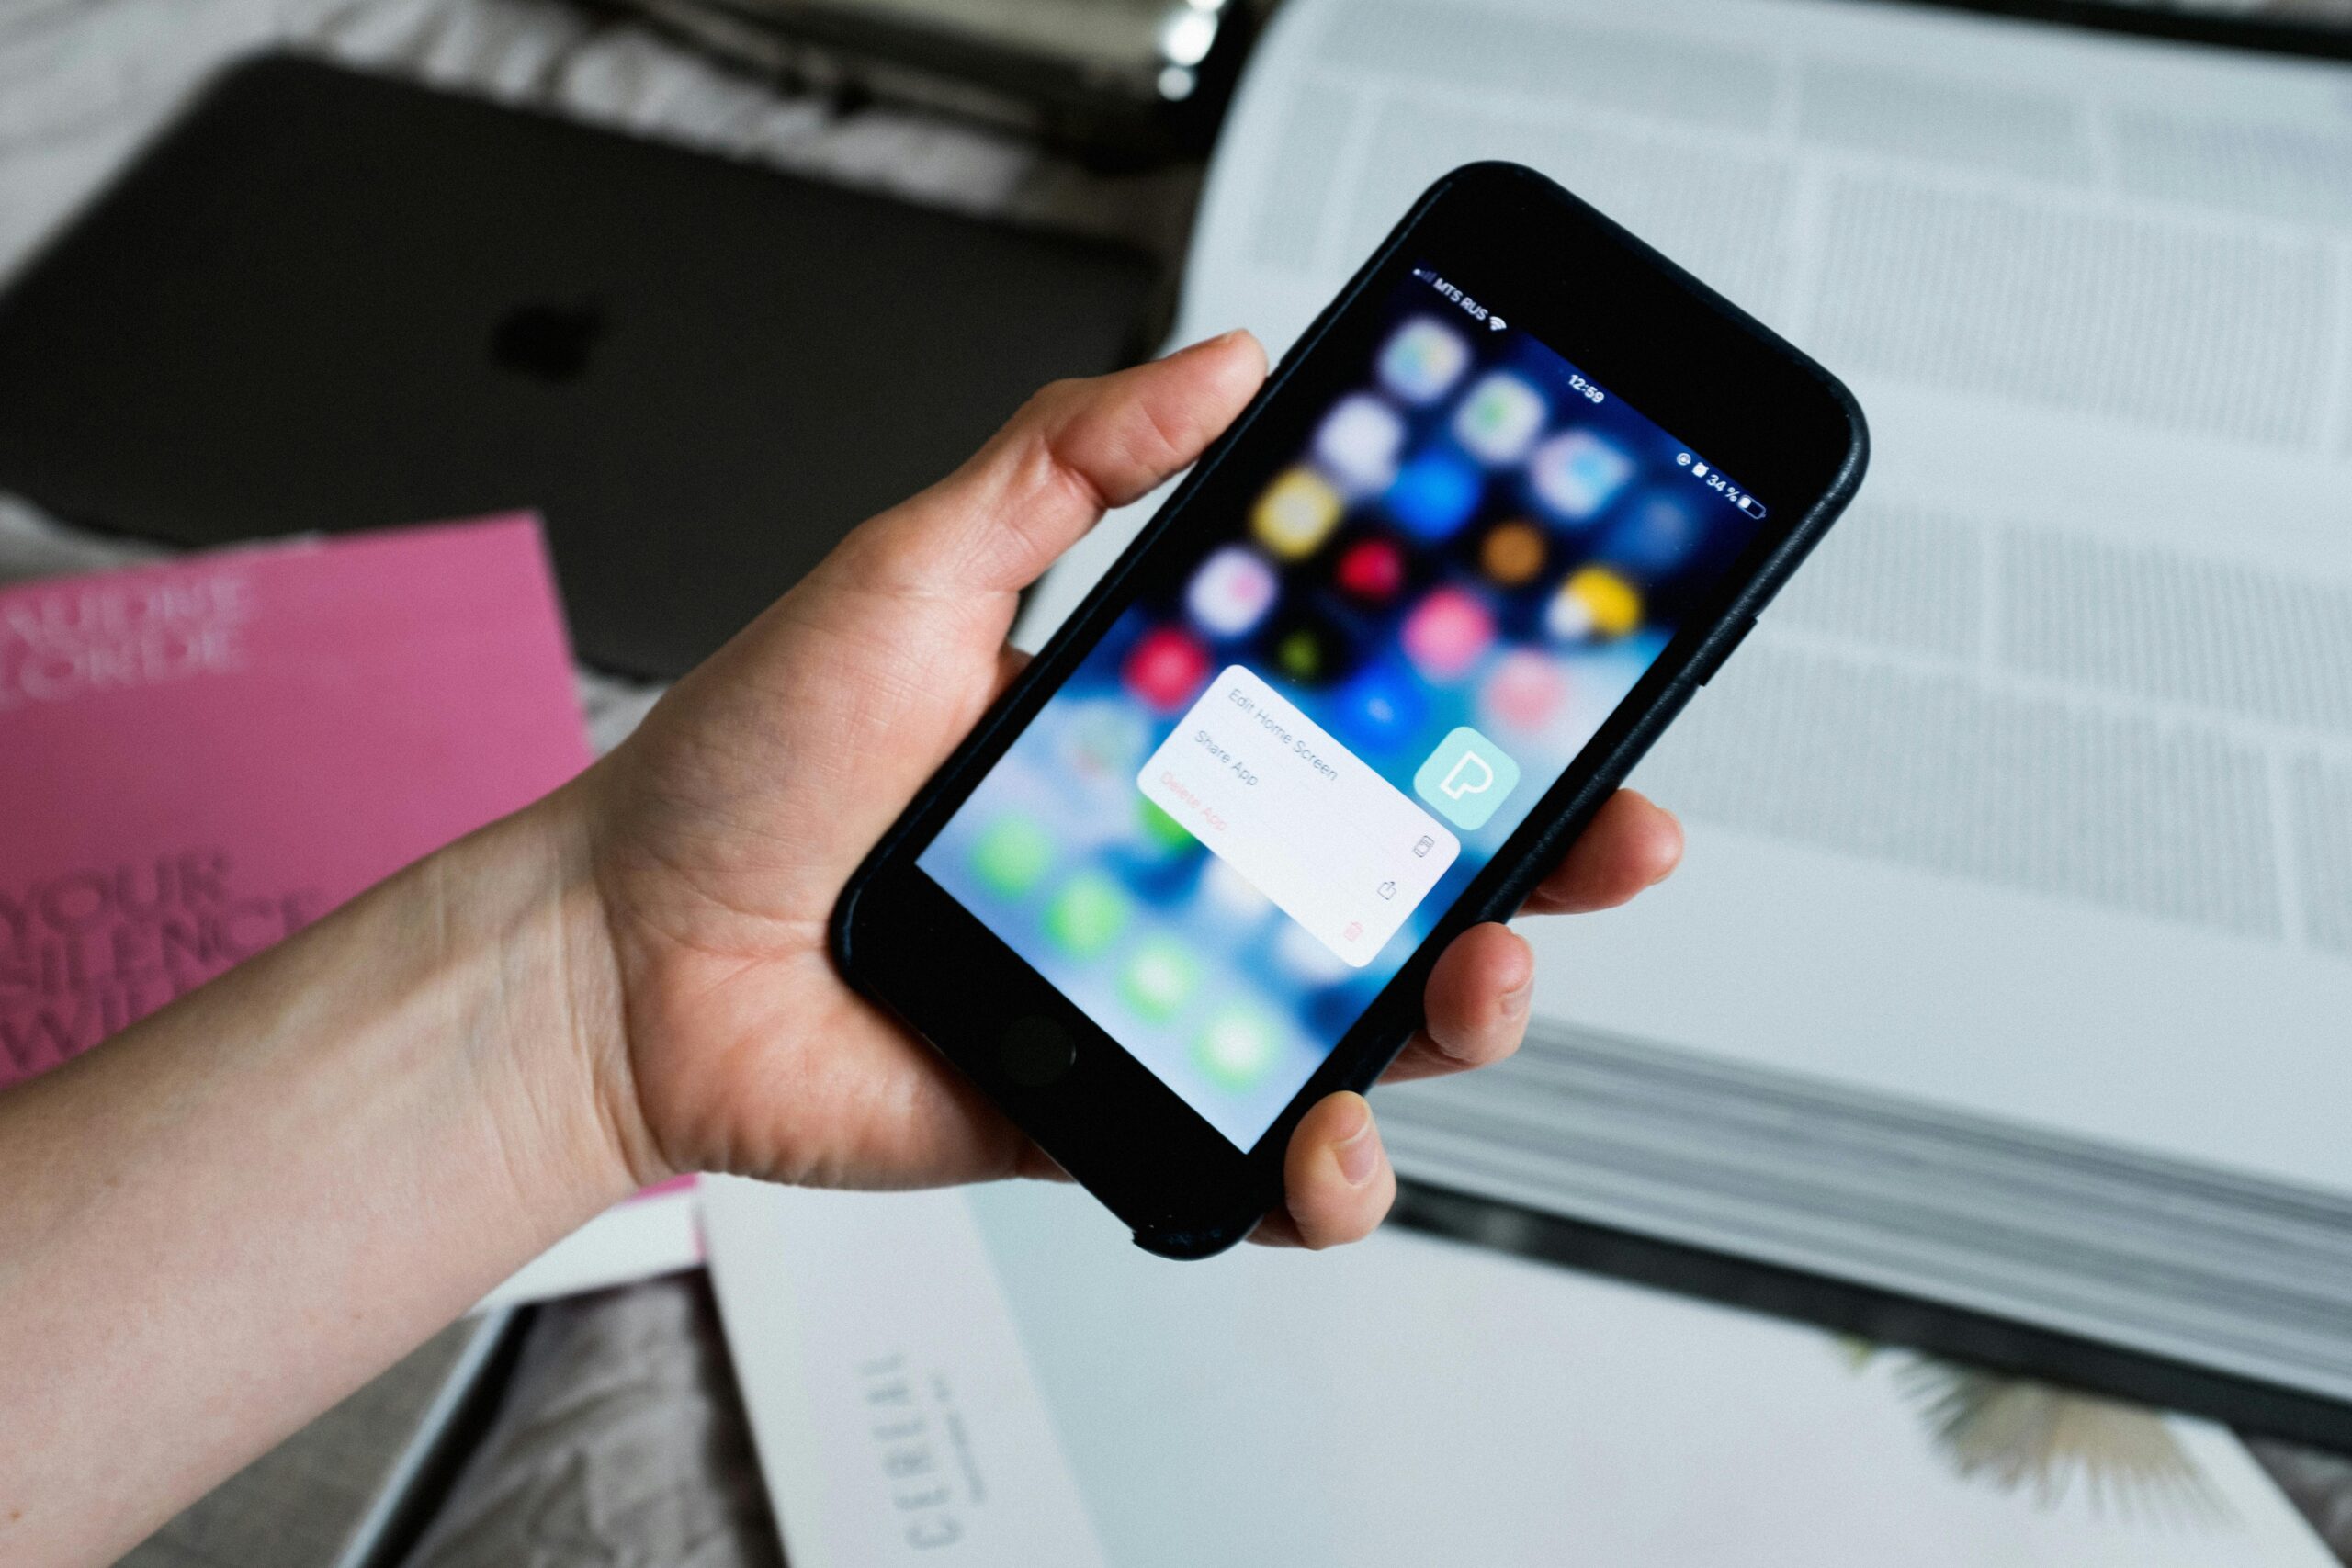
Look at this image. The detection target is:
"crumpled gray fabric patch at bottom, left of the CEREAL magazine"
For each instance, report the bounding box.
[404,1272,783,1568]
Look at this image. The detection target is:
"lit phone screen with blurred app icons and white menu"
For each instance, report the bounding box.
[917,265,1769,1152]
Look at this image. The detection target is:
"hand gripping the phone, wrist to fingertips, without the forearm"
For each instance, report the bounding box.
[558,333,1681,1246]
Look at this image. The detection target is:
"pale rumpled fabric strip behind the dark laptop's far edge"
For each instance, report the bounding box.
[0,0,1200,287]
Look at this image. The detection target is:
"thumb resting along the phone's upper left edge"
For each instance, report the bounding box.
[854,329,1265,592]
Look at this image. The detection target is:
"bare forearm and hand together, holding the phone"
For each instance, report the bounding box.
[0,333,1681,1565]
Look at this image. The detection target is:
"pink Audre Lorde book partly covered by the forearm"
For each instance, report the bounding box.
[0,514,698,1300]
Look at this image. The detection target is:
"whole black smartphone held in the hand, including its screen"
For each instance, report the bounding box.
[832,163,1868,1258]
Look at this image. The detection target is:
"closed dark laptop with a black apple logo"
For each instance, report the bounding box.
[0,56,1155,674]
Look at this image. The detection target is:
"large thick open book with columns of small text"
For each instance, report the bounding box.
[1023,0,2352,1437]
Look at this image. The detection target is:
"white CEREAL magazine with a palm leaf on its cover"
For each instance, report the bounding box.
[706,1180,2331,1568]
